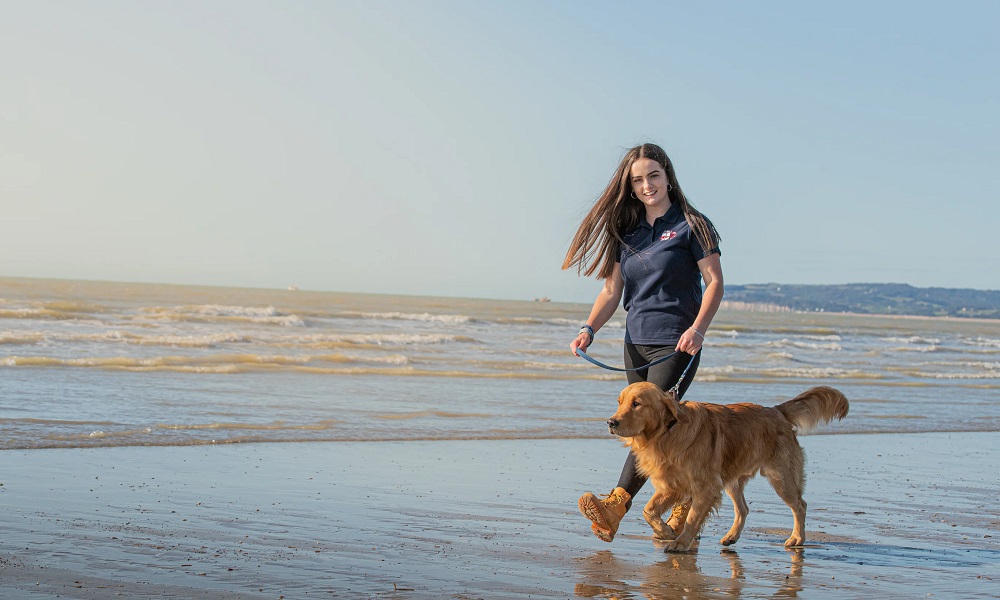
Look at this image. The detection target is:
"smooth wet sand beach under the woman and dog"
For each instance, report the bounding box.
[0,433,1000,599]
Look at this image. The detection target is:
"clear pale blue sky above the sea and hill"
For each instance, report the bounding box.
[0,0,1000,302]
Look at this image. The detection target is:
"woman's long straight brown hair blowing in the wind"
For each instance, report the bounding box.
[562,144,722,279]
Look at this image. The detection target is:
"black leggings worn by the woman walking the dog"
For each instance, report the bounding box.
[618,344,701,508]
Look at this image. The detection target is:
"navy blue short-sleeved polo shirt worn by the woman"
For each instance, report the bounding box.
[619,204,722,345]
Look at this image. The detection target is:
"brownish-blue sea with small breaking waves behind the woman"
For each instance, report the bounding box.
[0,278,1000,449]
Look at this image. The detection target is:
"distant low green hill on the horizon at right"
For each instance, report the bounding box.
[726,283,1000,319]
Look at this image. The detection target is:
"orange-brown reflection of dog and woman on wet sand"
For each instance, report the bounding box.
[574,542,805,600]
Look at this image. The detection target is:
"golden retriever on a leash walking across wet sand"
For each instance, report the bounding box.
[608,382,849,552]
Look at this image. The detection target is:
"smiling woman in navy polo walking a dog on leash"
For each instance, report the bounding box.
[562,144,723,542]
